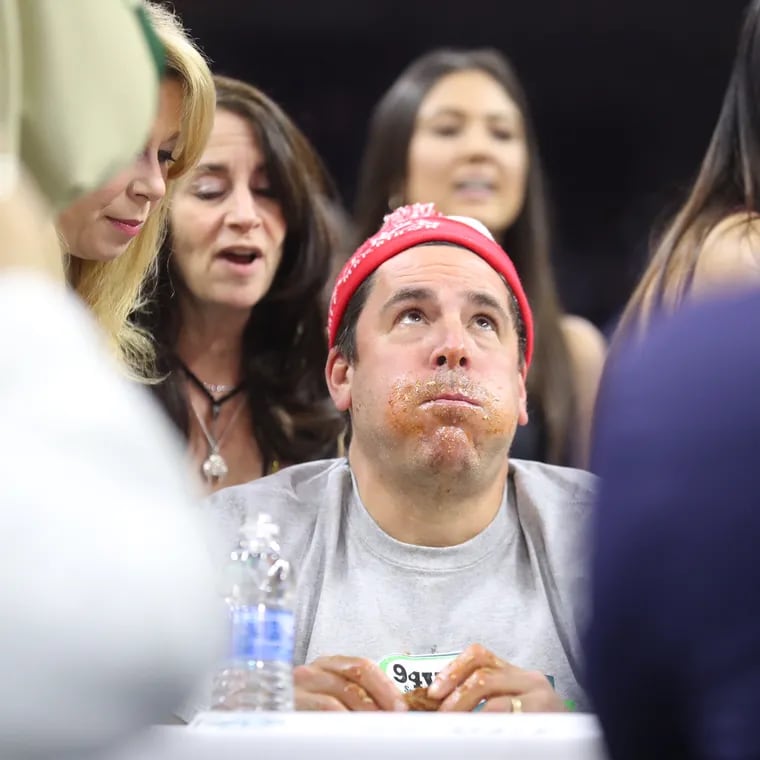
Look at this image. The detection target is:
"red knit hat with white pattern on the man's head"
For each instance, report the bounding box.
[327,203,533,368]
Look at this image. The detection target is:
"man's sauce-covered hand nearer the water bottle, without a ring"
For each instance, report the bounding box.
[293,656,407,711]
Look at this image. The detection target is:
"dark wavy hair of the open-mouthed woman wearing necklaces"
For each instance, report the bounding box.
[135,76,344,473]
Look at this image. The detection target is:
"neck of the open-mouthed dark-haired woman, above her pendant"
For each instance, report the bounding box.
[177,302,250,385]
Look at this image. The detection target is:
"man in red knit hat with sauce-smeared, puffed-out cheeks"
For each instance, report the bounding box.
[209,204,593,712]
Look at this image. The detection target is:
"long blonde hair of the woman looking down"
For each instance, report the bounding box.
[69,2,215,380]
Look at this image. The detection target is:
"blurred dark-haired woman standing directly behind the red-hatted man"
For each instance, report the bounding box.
[356,50,605,467]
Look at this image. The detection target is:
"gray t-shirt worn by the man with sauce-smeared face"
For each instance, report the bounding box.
[205,459,595,709]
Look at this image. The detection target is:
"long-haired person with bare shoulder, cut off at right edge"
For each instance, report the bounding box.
[616,0,760,338]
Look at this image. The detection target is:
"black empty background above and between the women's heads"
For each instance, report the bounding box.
[169,0,744,326]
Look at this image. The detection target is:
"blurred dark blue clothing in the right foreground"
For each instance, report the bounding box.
[585,294,760,760]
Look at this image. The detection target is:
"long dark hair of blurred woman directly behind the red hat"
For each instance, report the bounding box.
[355,49,575,464]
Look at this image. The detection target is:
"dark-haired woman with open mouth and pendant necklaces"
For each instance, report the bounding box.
[136,77,343,490]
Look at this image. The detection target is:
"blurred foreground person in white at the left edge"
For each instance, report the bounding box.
[0,0,222,760]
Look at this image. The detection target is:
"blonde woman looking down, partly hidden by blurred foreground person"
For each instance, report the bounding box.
[58,3,215,378]
